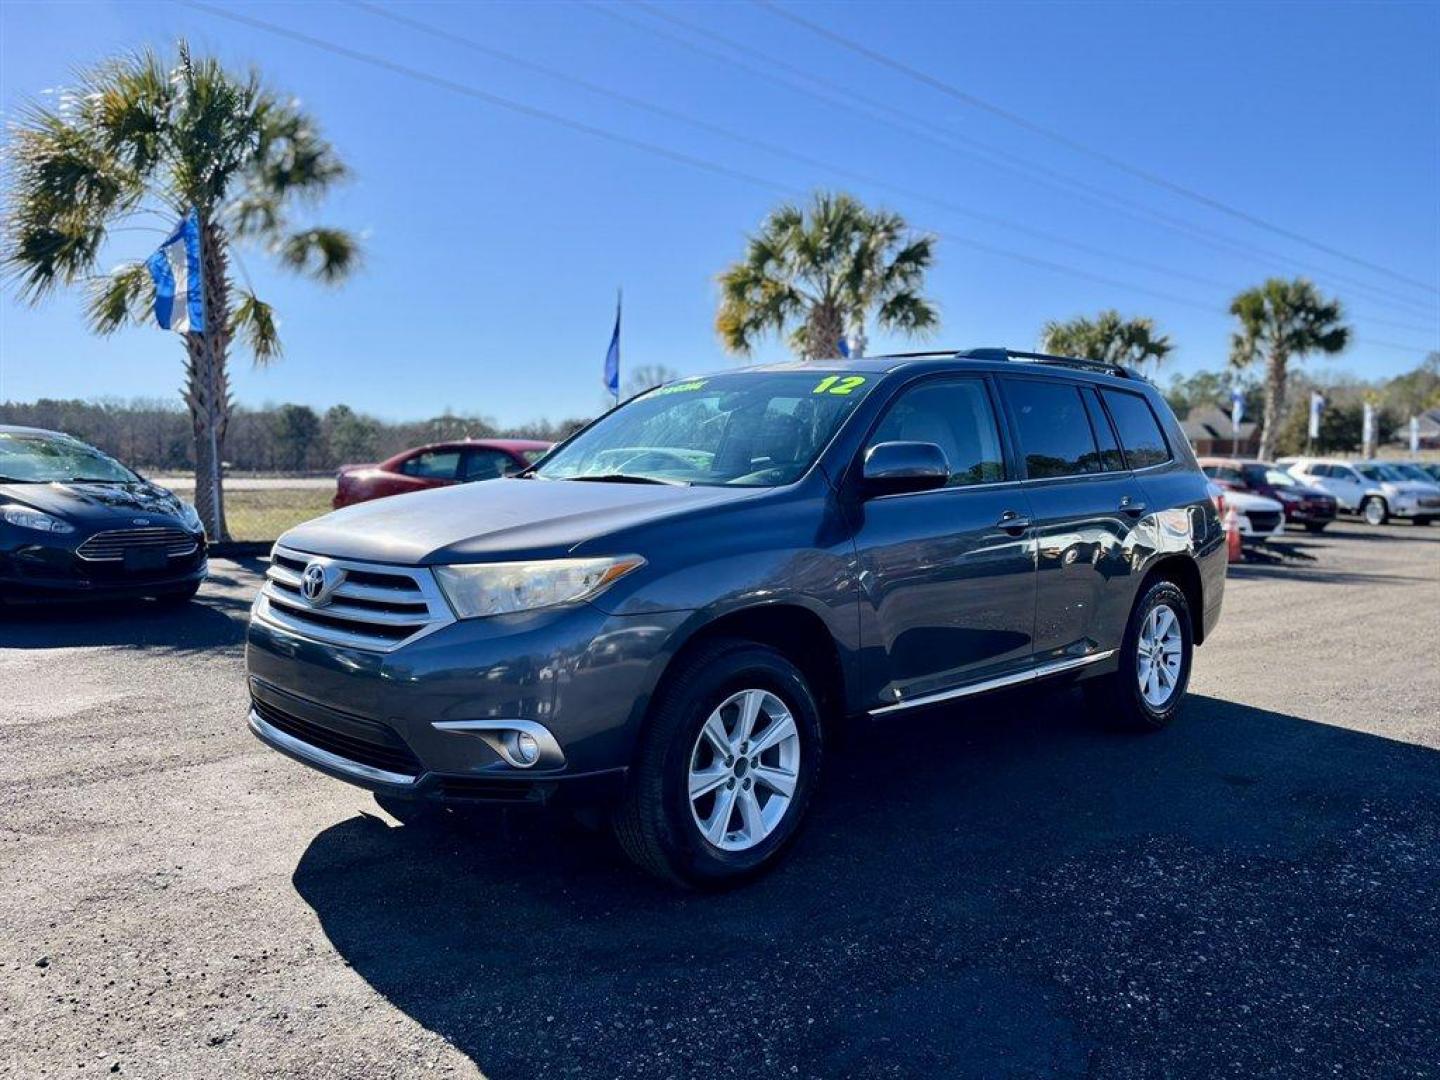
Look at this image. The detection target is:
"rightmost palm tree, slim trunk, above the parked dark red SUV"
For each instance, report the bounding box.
[1230,278,1349,458]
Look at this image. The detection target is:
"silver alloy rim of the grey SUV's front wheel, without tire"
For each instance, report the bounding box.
[685,690,801,851]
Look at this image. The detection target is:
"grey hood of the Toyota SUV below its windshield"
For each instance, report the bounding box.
[279,478,770,566]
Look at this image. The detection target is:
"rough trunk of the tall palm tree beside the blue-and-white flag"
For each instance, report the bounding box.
[184,215,230,541]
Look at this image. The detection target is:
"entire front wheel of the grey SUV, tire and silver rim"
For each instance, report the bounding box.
[613,641,821,888]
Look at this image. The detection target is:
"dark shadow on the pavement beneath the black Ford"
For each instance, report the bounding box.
[0,559,265,652]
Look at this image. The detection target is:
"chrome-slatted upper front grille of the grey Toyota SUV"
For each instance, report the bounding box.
[255,547,455,652]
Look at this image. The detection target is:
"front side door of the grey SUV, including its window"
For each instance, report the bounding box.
[855,377,1035,704]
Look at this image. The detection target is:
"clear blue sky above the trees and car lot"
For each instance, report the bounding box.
[0,0,1440,423]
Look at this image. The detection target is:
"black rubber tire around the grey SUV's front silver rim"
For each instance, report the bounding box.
[611,639,822,888]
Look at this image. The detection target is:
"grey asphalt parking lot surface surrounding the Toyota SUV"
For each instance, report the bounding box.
[0,524,1440,1077]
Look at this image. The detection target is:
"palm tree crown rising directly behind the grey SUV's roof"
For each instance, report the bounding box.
[716,192,939,360]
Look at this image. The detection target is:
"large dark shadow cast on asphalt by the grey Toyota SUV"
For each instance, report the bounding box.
[294,691,1440,1080]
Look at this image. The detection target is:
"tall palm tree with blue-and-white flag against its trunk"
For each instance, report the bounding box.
[0,42,360,540]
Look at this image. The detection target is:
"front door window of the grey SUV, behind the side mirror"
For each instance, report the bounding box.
[870,379,1005,487]
